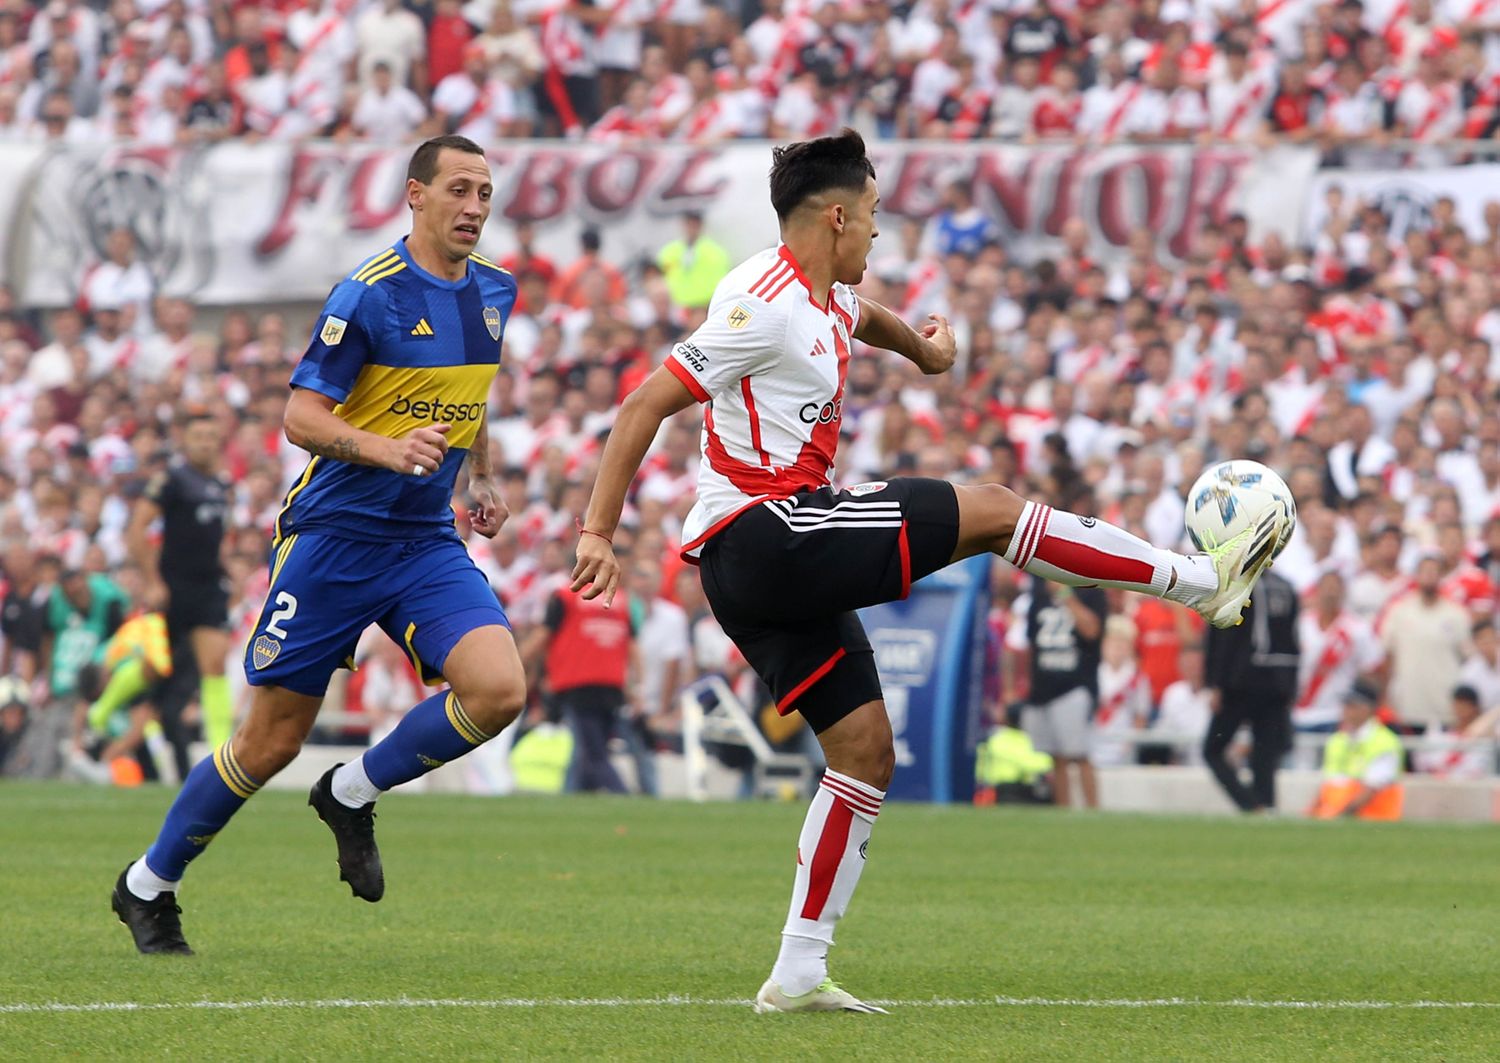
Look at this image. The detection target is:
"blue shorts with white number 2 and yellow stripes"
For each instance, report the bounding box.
[245,532,510,697]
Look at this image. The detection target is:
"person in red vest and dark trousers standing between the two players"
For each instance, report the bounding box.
[525,589,636,793]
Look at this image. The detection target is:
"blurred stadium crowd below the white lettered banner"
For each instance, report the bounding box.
[0,170,1500,772]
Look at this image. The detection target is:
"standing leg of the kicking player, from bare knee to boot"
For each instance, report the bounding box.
[755,702,896,1015]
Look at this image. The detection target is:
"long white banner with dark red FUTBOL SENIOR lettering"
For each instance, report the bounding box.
[0,141,1317,306]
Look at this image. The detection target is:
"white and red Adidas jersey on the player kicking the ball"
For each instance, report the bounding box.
[665,244,860,559]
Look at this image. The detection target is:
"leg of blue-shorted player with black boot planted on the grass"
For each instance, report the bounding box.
[110,687,323,955]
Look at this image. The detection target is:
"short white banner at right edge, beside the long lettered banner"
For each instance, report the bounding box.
[1299,163,1500,243]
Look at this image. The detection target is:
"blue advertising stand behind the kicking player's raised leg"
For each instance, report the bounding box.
[860,553,993,804]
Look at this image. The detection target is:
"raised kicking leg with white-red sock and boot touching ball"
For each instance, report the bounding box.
[954,484,1290,628]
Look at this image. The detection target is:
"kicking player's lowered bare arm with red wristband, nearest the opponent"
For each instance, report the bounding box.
[573,366,698,606]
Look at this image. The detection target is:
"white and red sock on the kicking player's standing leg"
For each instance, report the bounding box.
[771,771,885,997]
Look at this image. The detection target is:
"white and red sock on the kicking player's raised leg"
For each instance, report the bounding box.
[1005,502,1218,606]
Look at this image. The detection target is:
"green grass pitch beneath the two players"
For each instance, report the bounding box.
[0,784,1500,1060]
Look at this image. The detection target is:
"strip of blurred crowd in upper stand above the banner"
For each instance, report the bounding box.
[0,0,1500,151]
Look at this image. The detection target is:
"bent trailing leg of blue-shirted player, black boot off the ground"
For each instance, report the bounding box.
[316,624,527,901]
